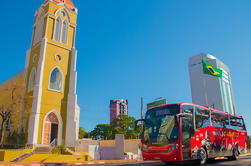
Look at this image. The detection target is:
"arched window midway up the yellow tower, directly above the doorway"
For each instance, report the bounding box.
[50,67,63,92]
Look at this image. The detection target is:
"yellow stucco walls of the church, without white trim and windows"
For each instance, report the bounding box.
[0,2,77,144]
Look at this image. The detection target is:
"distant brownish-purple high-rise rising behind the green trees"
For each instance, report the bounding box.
[110,99,128,122]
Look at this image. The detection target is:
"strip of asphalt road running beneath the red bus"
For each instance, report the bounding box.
[75,154,251,166]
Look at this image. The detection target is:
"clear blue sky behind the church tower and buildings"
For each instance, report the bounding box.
[0,0,251,135]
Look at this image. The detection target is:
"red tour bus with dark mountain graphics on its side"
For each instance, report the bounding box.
[135,103,249,164]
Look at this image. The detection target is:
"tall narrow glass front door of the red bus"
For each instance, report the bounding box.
[181,105,194,160]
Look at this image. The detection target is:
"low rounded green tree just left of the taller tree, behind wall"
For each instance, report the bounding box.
[90,124,112,140]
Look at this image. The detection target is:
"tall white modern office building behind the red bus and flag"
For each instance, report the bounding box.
[189,54,236,115]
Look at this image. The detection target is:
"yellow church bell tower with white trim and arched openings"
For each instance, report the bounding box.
[22,0,80,147]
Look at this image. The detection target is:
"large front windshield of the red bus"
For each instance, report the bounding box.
[142,105,179,146]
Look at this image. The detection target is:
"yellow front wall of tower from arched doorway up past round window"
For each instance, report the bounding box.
[38,44,71,144]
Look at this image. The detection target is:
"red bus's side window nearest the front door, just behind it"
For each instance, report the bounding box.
[195,107,211,129]
